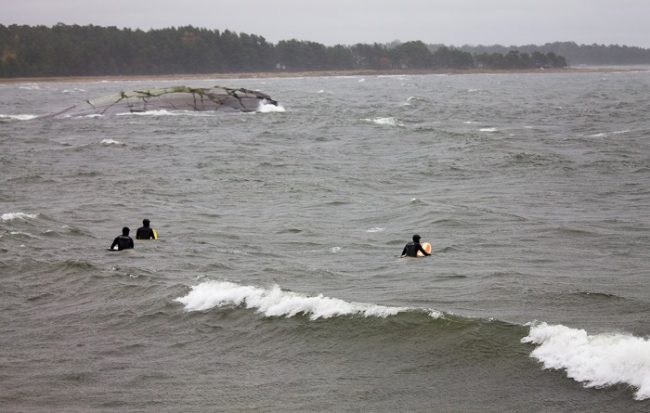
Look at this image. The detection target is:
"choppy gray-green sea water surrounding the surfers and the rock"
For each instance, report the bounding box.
[0,71,650,412]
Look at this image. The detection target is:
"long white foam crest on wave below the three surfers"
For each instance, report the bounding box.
[176,281,441,320]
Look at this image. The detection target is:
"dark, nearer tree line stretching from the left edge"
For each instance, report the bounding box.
[0,24,567,77]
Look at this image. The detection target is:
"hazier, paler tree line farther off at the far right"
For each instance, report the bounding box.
[459,42,650,66]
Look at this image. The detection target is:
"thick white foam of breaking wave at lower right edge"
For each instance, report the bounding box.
[521,323,650,400]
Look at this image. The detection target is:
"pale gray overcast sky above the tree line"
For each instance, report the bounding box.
[5,0,650,48]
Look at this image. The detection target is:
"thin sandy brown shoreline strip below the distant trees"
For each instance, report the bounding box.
[0,66,650,84]
